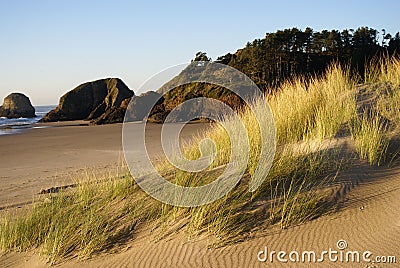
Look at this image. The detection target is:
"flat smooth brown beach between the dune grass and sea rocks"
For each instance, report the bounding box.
[0,121,207,208]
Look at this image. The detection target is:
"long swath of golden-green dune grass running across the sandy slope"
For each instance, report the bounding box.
[0,60,393,262]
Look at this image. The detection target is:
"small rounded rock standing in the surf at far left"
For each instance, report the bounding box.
[0,93,36,118]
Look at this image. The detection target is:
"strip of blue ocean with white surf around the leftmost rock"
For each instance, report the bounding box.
[0,105,56,135]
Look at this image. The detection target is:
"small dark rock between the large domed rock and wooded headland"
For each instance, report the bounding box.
[126,91,164,121]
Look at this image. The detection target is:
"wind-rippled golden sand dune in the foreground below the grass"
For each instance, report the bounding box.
[0,162,400,267]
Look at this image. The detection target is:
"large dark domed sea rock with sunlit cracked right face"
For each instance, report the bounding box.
[40,78,135,124]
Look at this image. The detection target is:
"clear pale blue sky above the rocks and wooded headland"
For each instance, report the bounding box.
[0,0,400,105]
